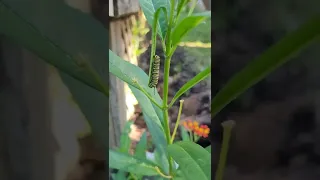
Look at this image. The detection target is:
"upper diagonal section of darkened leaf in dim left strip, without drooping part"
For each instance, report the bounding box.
[0,0,108,95]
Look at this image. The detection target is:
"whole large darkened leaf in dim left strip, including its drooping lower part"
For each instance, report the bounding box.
[0,0,109,147]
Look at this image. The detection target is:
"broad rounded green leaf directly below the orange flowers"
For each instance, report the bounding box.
[168,141,211,180]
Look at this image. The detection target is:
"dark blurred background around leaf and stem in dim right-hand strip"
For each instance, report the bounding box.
[212,0,320,180]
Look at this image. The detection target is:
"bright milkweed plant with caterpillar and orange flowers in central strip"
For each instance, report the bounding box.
[109,0,219,180]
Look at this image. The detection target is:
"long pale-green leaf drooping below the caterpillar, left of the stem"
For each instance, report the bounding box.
[109,47,167,169]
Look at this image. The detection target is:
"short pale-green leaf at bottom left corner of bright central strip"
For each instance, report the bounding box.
[109,149,158,176]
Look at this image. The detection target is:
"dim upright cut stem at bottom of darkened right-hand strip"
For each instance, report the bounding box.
[215,120,235,180]
